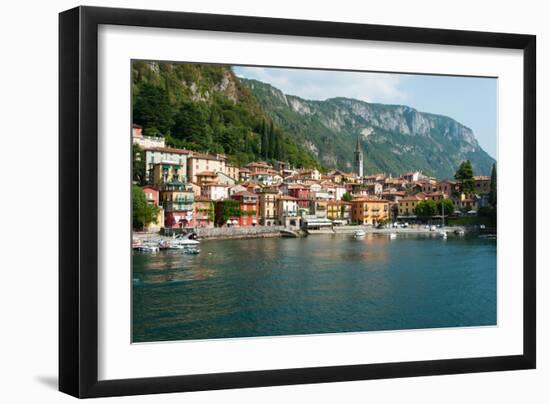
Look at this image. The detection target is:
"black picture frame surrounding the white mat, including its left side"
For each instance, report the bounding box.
[59,7,536,398]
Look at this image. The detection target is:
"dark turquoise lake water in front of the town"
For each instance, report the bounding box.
[132,235,496,342]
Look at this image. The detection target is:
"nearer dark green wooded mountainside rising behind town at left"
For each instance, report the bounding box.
[132,61,321,168]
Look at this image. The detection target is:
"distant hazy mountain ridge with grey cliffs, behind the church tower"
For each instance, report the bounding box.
[241,78,495,178]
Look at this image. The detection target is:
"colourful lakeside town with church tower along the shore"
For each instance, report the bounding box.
[132,124,496,243]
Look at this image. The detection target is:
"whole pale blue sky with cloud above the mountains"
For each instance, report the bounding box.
[234,66,497,158]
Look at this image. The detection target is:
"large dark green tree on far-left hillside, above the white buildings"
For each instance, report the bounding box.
[133,83,174,135]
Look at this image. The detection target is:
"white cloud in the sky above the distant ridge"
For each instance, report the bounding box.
[234,66,408,104]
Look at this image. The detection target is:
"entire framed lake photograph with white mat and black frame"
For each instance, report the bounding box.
[59,7,536,397]
